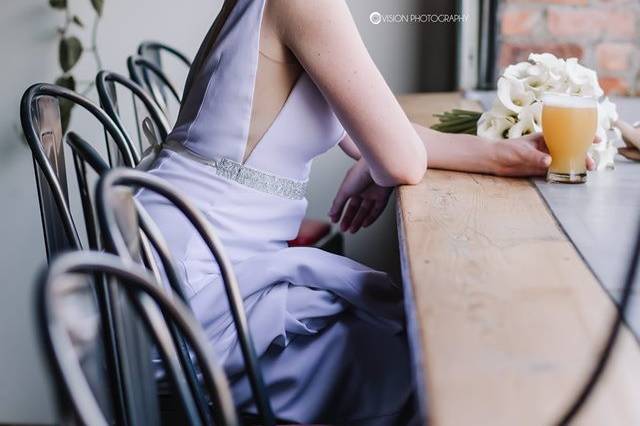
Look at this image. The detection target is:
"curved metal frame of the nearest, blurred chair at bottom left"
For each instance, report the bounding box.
[38,251,239,425]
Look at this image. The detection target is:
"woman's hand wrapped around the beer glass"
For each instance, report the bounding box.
[493,133,599,176]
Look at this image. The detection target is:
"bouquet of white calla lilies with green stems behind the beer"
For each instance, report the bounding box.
[433,53,619,170]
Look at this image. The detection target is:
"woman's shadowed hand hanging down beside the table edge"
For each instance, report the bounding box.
[329,160,393,233]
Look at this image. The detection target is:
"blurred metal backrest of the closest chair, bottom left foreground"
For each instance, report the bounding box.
[38,251,238,425]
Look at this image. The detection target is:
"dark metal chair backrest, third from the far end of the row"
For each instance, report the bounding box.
[96,71,170,160]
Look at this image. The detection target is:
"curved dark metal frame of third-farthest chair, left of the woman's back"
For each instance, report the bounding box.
[96,71,171,157]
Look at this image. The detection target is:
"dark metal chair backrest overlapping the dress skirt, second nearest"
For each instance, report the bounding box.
[96,168,275,425]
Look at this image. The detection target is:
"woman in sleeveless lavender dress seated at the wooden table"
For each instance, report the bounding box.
[139,0,596,424]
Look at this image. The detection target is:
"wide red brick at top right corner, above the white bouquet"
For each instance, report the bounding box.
[547,8,636,38]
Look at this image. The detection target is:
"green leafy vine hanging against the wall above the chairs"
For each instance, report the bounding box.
[49,0,104,132]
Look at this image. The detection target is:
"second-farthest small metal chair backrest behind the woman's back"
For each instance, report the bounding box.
[127,55,182,116]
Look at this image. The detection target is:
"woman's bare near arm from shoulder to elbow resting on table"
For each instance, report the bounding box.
[268,0,427,186]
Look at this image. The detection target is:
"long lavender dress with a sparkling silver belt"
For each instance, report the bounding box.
[138,0,412,425]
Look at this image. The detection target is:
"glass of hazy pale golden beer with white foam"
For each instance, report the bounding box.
[542,93,598,183]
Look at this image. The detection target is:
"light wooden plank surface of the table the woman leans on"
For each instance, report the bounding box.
[397,93,640,426]
